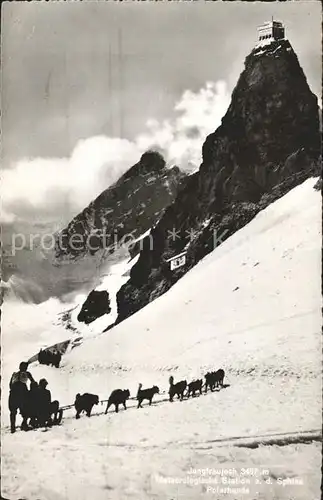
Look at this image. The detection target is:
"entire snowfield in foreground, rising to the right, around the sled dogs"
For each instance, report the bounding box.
[2,179,321,500]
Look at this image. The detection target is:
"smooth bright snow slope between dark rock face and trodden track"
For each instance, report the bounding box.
[57,179,320,375]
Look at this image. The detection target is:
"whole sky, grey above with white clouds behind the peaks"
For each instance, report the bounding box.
[1,1,321,222]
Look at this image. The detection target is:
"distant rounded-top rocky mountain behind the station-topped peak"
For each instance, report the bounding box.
[55,151,186,260]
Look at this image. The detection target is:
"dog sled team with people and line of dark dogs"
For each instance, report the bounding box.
[9,362,225,433]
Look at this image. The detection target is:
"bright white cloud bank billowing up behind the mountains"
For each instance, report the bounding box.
[2,81,230,222]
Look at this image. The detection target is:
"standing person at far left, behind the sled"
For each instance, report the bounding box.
[9,362,35,434]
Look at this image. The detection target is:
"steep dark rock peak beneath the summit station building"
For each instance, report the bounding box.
[117,40,321,322]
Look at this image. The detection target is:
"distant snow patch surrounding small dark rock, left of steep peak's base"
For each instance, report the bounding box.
[1,248,138,379]
